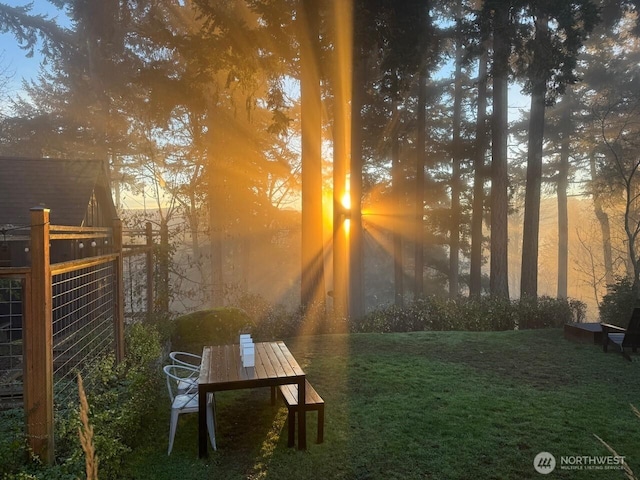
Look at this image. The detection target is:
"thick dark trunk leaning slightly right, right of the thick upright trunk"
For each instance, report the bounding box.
[520,15,549,298]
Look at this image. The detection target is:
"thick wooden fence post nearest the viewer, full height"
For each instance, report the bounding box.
[23,207,54,464]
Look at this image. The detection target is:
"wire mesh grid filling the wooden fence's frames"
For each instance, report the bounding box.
[0,252,154,408]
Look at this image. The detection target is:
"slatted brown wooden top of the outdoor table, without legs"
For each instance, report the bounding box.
[198,341,305,390]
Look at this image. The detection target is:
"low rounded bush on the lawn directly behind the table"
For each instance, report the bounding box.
[171,307,255,353]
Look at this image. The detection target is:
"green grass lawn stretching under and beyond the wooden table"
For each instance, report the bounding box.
[122,329,640,480]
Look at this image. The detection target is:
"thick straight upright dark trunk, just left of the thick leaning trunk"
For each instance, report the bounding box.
[490,6,510,298]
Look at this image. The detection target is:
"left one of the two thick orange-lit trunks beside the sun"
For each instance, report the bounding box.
[298,0,325,309]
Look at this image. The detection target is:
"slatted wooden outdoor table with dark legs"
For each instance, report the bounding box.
[198,341,307,458]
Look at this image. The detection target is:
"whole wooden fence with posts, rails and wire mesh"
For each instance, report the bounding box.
[0,211,154,463]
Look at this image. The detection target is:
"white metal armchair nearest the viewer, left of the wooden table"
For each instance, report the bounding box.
[164,365,217,455]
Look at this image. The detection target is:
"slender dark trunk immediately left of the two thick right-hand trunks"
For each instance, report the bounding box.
[469,49,488,297]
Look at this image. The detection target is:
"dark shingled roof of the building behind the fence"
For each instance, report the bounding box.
[0,157,115,226]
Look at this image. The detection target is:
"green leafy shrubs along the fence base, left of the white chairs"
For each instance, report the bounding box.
[0,324,162,480]
